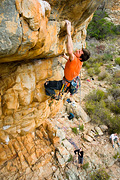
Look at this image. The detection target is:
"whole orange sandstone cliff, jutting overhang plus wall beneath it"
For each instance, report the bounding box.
[0,0,102,143]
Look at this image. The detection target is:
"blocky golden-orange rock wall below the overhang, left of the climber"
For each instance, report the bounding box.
[0,58,63,143]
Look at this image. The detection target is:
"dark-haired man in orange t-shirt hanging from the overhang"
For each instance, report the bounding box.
[44,20,90,100]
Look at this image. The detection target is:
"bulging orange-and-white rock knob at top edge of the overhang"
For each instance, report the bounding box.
[16,0,51,31]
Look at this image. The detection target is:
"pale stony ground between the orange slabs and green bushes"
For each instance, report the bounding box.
[50,65,120,180]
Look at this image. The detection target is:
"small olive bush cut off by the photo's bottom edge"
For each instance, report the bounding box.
[91,169,110,180]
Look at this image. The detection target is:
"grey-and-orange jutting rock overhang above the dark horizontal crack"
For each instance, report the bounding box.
[0,0,102,62]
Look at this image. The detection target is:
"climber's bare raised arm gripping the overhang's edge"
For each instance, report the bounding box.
[65,20,74,61]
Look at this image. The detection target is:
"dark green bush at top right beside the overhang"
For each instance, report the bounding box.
[87,10,120,40]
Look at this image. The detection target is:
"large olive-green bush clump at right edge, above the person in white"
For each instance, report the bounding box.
[85,86,120,133]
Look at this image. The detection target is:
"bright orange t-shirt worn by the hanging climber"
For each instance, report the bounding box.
[64,56,83,81]
